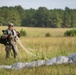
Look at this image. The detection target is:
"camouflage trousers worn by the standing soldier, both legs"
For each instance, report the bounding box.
[5,45,18,58]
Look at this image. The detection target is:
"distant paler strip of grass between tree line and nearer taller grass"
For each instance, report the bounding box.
[0,26,74,37]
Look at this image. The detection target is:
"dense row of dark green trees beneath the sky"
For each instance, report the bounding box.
[0,5,76,28]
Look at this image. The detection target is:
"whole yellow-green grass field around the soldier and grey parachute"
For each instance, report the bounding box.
[0,27,76,75]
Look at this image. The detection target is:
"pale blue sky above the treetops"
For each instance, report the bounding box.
[0,0,76,9]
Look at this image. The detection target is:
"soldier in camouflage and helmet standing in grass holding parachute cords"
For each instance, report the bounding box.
[2,23,18,58]
